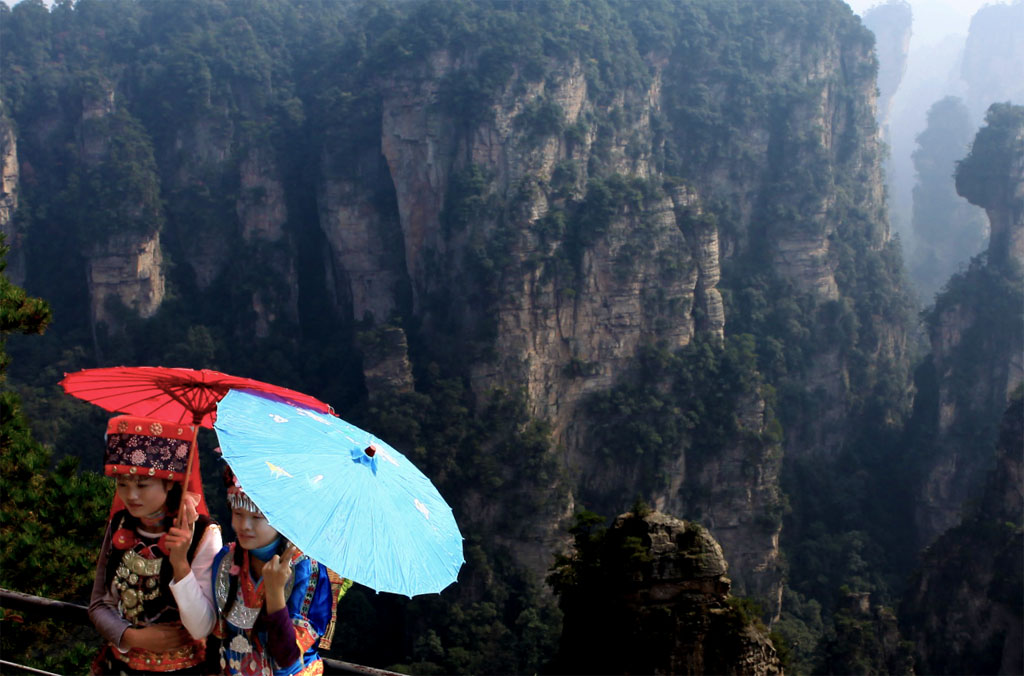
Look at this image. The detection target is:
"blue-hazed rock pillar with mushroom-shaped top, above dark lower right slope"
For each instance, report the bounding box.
[916,104,1024,545]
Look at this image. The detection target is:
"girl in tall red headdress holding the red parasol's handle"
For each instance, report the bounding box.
[89,416,222,674]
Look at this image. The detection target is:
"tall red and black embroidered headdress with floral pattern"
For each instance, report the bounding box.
[103,416,196,481]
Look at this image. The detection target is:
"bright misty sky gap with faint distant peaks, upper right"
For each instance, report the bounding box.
[864,1,1024,303]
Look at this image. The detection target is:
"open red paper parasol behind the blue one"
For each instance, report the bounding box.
[60,367,334,510]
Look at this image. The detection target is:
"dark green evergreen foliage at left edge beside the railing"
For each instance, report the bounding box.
[0,238,112,673]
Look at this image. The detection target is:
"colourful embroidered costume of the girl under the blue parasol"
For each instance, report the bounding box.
[213,543,331,676]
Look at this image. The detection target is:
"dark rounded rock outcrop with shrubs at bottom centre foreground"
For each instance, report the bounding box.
[555,512,782,675]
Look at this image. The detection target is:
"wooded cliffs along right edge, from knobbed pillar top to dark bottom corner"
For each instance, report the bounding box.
[888,103,1024,673]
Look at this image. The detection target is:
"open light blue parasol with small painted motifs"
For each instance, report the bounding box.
[214,390,465,596]
